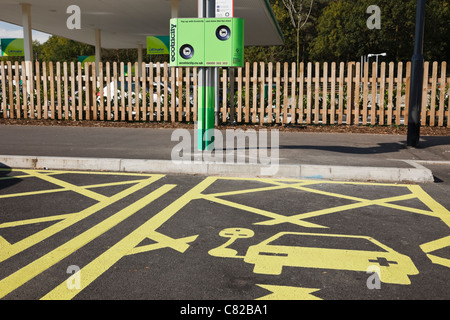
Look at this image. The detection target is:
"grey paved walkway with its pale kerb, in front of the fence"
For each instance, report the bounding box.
[0,126,450,182]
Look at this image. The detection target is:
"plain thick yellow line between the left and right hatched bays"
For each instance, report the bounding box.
[0,185,175,298]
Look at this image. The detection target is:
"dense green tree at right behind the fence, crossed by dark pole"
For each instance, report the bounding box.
[309,0,450,61]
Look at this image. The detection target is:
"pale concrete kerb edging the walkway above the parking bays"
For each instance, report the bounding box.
[0,155,434,183]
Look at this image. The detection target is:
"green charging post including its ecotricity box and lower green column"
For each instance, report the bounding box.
[170,18,244,150]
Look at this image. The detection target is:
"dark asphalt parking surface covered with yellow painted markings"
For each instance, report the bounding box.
[0,166,450,306]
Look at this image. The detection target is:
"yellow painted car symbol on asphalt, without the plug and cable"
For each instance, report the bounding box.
[244,232,419,284]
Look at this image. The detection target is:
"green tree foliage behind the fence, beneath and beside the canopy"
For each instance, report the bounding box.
[1,0,450,62]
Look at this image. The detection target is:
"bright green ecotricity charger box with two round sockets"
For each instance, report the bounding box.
[170,18,244,67]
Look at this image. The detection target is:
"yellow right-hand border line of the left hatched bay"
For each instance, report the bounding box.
[0,175,163,262]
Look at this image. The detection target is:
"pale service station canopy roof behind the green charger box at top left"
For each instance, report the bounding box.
[0,0,283,49]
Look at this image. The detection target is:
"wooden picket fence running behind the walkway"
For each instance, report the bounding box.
[0,61,450,127]
